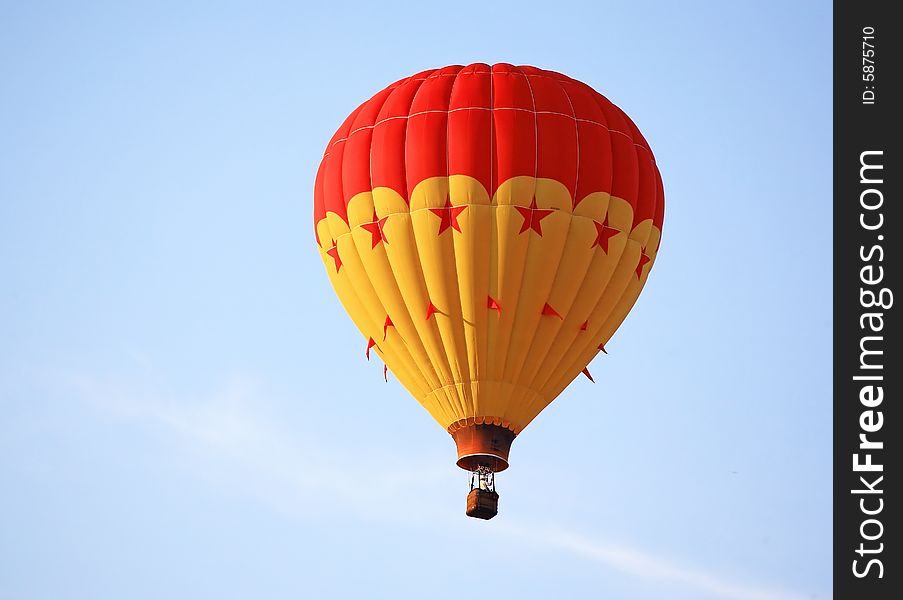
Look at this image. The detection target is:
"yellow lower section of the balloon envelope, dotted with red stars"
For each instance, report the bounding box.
[317,175,661,433]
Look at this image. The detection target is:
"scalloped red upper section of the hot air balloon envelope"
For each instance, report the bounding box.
[314,64,664,239]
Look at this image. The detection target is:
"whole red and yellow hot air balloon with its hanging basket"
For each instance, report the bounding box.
[314,64,664,519]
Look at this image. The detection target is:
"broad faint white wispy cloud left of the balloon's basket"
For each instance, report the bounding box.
[75,377,452,519]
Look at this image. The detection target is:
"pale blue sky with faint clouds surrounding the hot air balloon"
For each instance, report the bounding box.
[0,1,832,600]
